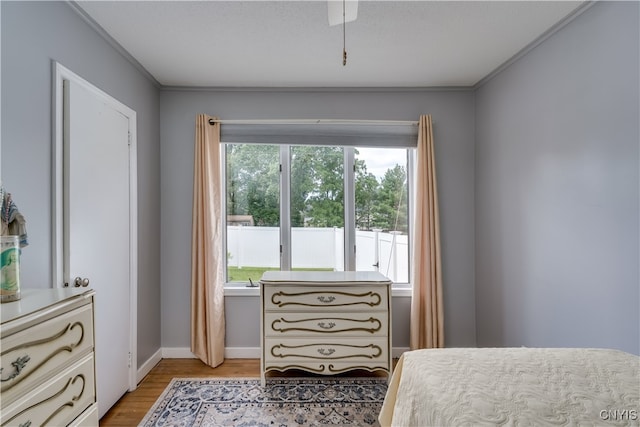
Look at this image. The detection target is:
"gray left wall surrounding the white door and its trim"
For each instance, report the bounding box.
[1,1,160,363]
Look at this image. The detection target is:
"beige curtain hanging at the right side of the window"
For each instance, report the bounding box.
[409,116,444,350]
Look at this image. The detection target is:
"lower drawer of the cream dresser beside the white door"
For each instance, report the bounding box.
[1,354,95,426]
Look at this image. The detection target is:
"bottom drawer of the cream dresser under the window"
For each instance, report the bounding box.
[265,337,388,361]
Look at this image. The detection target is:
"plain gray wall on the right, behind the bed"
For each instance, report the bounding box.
[475,2,640,354]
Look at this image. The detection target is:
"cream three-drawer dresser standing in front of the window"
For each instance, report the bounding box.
[260,271,392,386]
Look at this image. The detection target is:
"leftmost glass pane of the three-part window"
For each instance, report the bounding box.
[226,144,280,284]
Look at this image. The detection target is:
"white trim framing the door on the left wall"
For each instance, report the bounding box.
[51,60,138,391]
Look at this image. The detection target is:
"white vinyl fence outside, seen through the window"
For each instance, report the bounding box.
[227,226,409,283]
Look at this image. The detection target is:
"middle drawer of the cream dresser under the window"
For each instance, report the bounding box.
[264,311,389,337]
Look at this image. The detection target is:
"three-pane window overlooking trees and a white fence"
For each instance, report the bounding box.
[224,143,412,283]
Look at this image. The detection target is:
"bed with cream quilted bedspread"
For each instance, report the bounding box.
[379,348,640,427]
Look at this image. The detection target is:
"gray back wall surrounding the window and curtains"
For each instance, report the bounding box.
[160,89,475,347]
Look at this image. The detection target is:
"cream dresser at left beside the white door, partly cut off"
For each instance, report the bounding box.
[0,288,98,427]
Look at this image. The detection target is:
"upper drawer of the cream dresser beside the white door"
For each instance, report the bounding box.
[0,304,93,407]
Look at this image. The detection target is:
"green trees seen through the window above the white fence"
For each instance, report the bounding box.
[226,144,407,232]
